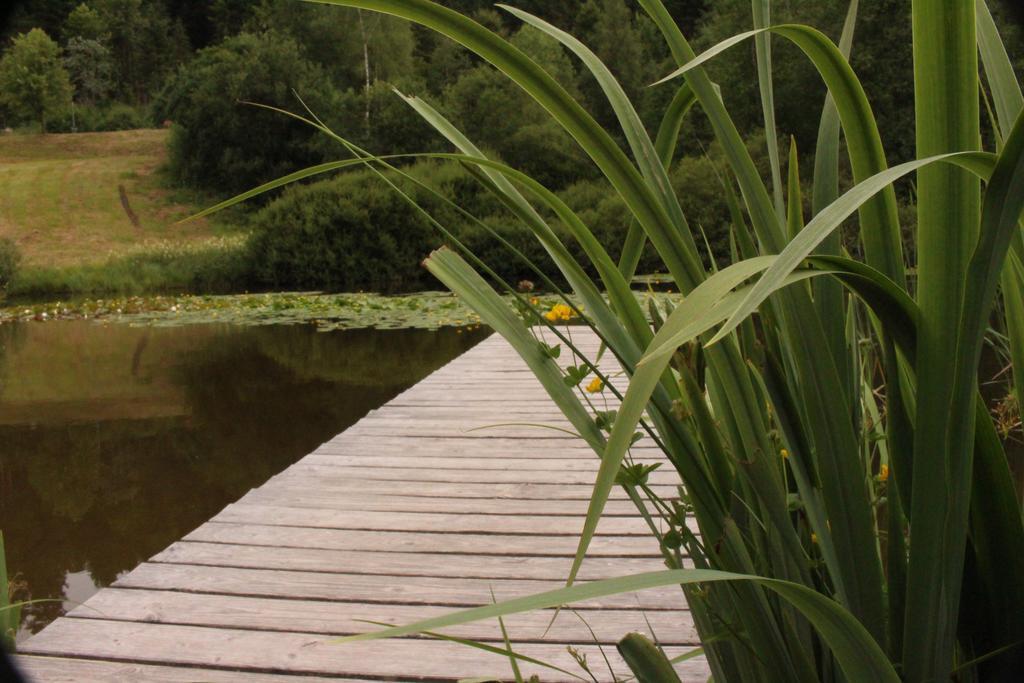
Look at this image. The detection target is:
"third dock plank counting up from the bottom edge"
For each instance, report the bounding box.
[71,588,697,645]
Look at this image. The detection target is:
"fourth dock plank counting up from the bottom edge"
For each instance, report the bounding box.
[112,562,685,610]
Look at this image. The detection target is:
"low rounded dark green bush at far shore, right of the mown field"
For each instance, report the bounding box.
[250,163,656,291]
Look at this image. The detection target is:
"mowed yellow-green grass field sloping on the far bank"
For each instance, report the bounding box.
[0,130,224,267]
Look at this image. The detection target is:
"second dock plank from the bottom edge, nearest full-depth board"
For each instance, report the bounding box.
[24,618,707,681]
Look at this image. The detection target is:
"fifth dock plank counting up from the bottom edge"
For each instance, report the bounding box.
[150,541,665,581]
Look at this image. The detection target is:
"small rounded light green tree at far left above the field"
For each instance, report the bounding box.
[0,29,72,133]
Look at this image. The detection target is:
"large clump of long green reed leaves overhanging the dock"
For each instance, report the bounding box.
[207,0,1024,683]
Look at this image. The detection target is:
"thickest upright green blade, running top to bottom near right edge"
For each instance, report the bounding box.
[903,0,987,681]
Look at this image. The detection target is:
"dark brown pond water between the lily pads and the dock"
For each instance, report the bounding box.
[0,321,486,638]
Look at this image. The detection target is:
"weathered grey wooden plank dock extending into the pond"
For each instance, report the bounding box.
[18,331,709,683]
